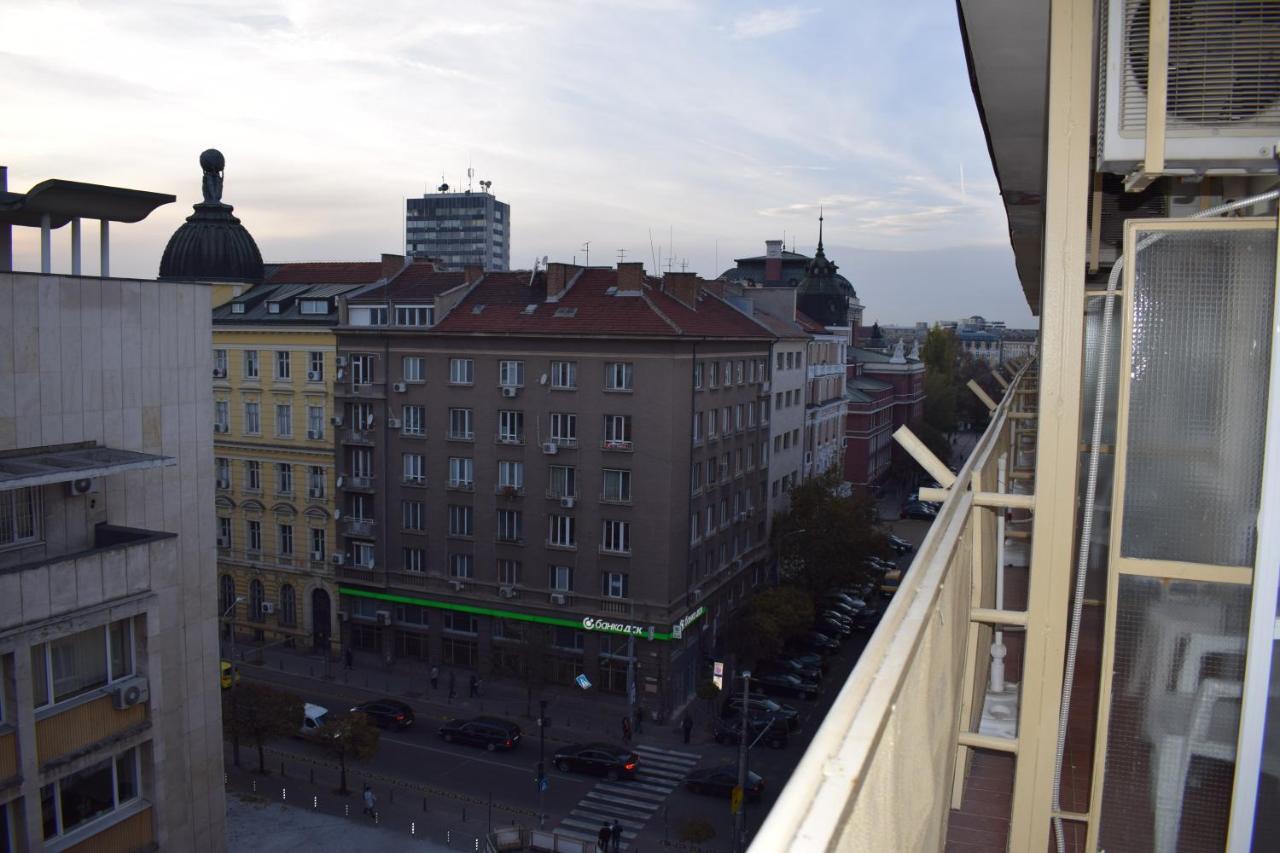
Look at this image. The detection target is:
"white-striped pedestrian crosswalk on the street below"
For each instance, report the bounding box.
[554,744,700,850]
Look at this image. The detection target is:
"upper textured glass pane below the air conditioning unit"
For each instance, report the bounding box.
[1120,231,1276,566]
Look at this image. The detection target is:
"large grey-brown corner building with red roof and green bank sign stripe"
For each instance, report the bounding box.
[335,264,774,713]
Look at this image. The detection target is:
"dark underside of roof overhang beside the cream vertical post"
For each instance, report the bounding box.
[956,0,1050,316]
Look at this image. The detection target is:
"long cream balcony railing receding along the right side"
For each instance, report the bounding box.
[751,358,1025,853]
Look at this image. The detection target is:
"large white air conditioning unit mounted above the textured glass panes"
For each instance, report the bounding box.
[1098,0,1280,174]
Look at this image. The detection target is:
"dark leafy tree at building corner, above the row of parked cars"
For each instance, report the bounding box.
[773,470,888,598]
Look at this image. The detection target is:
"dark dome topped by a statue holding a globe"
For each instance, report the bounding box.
[160,149,262,283]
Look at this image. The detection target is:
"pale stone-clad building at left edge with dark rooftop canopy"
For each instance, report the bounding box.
[0,172,225,852]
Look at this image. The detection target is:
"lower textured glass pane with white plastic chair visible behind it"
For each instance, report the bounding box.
[1100,575,1249,853]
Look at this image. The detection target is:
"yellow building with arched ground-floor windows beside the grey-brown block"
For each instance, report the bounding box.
[212,255,404,648]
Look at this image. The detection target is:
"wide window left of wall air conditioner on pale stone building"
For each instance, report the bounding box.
[31,614,133,708]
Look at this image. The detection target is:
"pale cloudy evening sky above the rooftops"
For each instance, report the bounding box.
[0,0,1034,327]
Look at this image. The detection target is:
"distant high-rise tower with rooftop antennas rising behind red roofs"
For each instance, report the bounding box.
[404,188,511,270]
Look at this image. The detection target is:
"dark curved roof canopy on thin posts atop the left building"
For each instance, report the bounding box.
[0,178,177,228]
